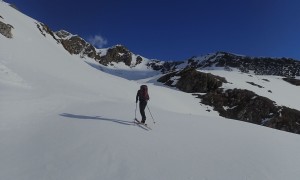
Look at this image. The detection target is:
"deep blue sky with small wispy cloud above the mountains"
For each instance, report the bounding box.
[4,0,300,60]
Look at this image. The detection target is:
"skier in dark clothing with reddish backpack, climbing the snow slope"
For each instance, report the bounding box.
[135,85,149,124]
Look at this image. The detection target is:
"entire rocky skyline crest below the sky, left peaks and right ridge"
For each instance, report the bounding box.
[42,27,300,85]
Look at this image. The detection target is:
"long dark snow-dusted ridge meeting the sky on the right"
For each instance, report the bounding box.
[188,52,300,78]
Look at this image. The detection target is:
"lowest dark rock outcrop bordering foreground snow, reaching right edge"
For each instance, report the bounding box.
[198,89,300,134]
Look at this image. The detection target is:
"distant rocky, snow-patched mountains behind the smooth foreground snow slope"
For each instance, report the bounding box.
[49,24,300,134]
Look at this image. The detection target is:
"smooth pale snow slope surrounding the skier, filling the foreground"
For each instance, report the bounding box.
[0,2,300,180]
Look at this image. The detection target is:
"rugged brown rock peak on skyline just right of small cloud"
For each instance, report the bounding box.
[99,45,132,66]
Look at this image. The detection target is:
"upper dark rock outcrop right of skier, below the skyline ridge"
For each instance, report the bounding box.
[158,68,227,93]
